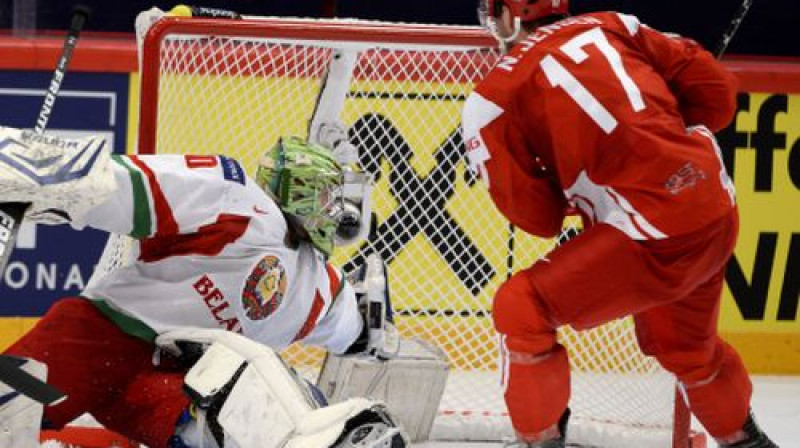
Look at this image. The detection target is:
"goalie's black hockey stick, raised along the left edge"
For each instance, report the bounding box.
[0,6,89,405]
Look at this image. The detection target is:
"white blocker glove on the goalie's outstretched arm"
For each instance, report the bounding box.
[0,127,116,224]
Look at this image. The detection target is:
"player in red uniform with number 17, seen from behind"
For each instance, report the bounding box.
[463,0,775,448]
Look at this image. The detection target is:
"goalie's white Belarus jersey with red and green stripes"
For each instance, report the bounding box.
[79,155,362,353]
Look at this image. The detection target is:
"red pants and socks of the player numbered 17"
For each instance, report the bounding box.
[493,211,752,437]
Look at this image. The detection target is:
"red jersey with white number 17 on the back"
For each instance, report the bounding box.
[463,12,736,240]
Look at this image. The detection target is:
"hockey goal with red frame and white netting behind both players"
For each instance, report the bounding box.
[126,17,699,448]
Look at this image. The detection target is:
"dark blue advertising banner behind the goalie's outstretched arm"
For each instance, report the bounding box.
[0,70,129,316]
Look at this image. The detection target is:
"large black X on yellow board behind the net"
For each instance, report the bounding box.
[344,114,496,295]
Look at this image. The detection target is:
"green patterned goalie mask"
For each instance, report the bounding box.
[256,137,343,255]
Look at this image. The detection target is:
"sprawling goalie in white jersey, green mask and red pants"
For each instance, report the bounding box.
[0,127,405,448]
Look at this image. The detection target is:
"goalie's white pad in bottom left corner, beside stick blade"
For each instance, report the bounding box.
[0,359,47,448]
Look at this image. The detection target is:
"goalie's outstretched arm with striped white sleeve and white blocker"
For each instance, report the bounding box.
[0,127,268,239]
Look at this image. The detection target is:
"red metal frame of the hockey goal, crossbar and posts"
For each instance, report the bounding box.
[133,17,705,448]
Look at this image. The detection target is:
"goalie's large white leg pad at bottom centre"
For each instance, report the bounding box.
[156,329,408,448]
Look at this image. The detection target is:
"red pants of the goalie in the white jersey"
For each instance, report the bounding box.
[6,297,189,448]
